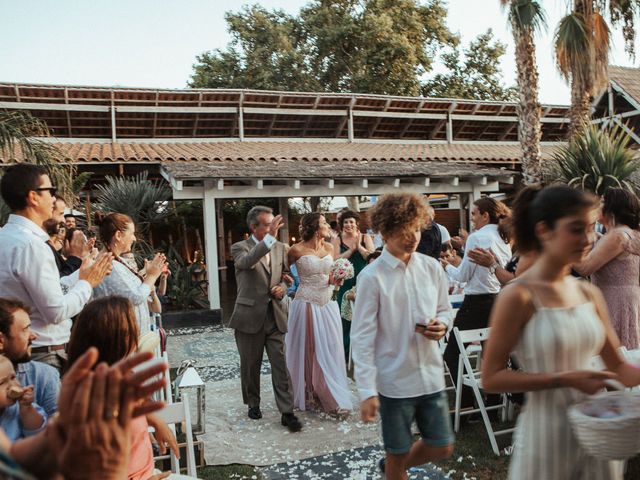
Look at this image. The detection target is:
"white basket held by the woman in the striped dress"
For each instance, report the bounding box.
[568,392,640,460]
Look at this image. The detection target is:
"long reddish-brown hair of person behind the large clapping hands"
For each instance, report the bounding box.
[67,296,139,366]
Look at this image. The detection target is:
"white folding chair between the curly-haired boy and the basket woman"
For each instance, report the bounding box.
[453,327,514,455]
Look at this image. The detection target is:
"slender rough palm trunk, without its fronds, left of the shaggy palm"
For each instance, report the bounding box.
[512,25,542,185]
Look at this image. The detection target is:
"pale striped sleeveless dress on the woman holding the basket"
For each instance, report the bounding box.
[509,292,622,480]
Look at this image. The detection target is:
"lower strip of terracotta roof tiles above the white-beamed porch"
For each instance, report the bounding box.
[0,141,553,168]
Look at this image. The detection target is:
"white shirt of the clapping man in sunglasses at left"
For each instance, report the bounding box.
[0,215,91,347]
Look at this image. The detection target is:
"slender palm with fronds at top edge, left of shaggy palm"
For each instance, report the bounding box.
[500,0,545,185]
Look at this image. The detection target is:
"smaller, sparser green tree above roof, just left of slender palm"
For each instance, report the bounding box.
[422,29,518,100]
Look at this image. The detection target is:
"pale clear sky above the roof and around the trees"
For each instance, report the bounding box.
[0,0,640,104]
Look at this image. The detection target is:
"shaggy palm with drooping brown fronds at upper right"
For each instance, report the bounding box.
[554,0,640,138]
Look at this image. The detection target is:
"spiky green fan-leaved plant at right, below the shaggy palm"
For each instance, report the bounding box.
[553,125,640,195]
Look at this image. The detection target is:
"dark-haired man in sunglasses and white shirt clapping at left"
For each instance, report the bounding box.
[0,164,112,370]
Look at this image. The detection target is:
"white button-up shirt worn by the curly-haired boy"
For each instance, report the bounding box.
[351,248,453,400]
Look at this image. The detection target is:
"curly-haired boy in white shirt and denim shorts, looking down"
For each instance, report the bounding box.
[351,194,454,480]
